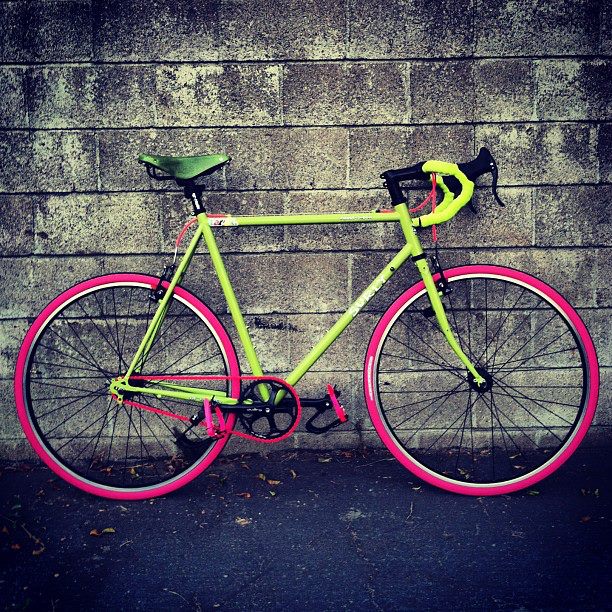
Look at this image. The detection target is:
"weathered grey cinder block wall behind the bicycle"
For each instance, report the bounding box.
[0,0,612,455]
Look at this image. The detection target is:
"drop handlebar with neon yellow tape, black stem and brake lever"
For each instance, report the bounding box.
[381,147,504,227]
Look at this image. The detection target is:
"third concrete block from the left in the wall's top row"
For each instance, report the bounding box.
[219,0,346,60]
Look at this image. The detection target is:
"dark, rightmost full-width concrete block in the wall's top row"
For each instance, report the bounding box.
[474,0,599,56]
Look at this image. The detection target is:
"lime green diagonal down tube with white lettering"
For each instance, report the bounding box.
[286,244,412,387]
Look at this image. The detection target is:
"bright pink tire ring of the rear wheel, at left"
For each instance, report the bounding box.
[14,273,240,500]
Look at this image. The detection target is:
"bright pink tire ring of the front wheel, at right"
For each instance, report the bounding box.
[363,265,599,496]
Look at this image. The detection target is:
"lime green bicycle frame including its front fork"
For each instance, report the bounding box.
[111,203,484,405]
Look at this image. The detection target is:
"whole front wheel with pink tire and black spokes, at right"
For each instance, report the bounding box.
[364,265,599,495]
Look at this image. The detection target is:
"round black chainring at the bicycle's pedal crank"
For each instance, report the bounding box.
[238,377,300,440]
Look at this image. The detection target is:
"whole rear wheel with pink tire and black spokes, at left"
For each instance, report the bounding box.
[15,274,239,499]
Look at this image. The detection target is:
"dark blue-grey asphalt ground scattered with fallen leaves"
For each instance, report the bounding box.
[0,449,612,611]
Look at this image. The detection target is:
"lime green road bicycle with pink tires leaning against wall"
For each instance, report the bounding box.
[14,148,599,499]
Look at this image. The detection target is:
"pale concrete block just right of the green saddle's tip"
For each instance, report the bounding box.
[222,128,348,189]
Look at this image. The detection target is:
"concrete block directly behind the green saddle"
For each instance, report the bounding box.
[98,129,227,193]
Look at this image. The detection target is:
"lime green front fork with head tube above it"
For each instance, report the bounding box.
[395,203,486,386]
